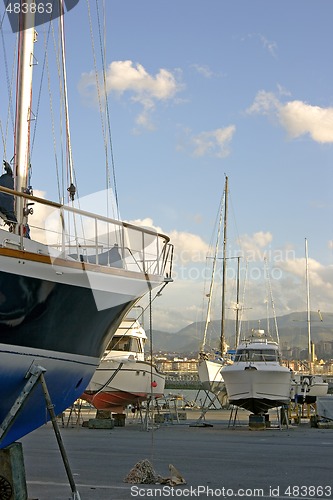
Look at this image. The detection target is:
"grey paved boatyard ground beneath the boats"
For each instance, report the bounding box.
[21,411,333,500]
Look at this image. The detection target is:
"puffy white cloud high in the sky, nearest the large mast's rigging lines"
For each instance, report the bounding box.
[79,60,183,129]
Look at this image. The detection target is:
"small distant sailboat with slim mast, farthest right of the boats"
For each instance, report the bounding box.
[292,238,328,404]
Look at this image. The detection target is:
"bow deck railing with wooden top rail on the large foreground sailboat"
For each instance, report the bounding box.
[0,186,173,280]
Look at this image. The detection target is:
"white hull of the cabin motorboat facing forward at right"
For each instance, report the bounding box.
[223,363,291,415]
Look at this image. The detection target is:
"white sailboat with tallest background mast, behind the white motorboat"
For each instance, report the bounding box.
[198,177,228,404]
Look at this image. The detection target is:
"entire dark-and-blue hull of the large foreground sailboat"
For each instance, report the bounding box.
[0,248,163,448]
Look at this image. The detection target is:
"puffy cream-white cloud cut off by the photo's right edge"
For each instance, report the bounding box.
[247,90,333,143]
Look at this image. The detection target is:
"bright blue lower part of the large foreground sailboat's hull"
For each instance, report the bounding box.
[0,344,99,448]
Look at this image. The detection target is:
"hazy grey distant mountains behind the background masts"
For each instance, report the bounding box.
[148,312,333,353]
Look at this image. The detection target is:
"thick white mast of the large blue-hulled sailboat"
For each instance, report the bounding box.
[14,0,35,228]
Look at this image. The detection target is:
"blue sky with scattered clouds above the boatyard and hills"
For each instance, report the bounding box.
[0,0,333,338]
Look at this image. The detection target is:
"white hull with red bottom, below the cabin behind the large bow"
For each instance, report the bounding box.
[81,361,165,413]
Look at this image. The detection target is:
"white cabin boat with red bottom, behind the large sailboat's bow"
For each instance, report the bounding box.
[81,318,165,413]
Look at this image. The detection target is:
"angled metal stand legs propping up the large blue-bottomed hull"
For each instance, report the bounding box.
[0,364,81,500]
